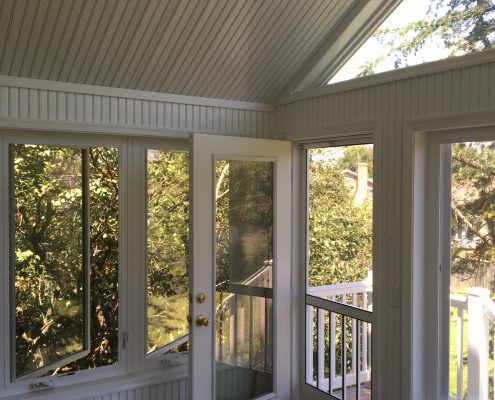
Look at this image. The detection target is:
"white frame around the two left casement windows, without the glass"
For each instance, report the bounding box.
[0,130,189,400]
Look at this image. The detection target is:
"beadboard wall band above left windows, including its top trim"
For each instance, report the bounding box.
[0,76,274,138]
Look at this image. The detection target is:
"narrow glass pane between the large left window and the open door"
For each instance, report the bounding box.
[147,150,189,353]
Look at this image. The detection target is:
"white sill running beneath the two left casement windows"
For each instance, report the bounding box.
[0,364,188,400]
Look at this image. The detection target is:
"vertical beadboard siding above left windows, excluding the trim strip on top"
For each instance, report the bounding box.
[0,85,274,138]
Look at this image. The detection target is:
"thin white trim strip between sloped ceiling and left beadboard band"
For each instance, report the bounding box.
[0,75,275,112]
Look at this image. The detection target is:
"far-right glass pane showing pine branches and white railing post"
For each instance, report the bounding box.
[449,141,495,399]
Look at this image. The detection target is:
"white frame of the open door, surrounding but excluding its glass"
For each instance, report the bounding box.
[189,134,294,400]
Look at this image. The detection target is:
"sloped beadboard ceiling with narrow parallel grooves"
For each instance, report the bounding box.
[0,0,398,103]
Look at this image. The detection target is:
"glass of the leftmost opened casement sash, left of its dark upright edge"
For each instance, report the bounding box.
[13,145,85,378]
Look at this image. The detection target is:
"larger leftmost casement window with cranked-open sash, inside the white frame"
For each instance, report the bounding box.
[10,144,119,380]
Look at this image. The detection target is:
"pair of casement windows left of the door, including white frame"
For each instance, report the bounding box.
[0,133,194,396]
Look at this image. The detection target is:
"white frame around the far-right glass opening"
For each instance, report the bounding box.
[410,121,495,400]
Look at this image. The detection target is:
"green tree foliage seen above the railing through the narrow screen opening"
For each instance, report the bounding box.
[309,149,372,286]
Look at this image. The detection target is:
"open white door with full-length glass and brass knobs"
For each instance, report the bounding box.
[189,134,292,400]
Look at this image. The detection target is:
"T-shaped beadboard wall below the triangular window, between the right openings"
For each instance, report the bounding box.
[275,52,495,399]
